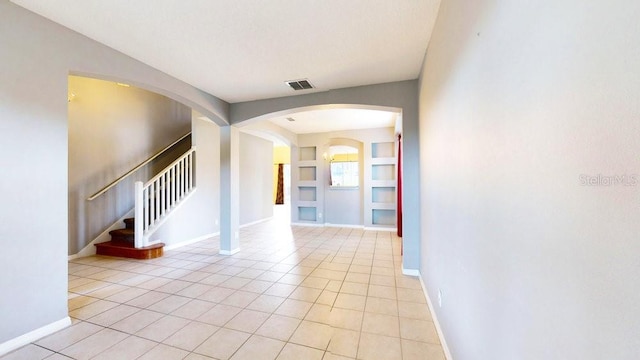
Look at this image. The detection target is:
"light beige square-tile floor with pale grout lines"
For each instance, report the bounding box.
[1,217,444,360]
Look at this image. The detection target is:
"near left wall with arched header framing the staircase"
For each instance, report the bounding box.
[0,1,228,352]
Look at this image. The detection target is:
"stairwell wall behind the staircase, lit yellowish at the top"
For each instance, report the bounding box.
[68,76,191,254]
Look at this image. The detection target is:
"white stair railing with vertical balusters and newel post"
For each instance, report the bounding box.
[134,147,196,248]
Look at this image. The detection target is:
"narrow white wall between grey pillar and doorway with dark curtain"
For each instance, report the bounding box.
[240,132,273,225]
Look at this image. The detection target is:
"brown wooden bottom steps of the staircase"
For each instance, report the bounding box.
[95,218,164,259]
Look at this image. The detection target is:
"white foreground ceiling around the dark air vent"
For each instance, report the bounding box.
[12,0,440,132]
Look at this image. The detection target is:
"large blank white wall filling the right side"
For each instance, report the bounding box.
[420,0,640,360]
